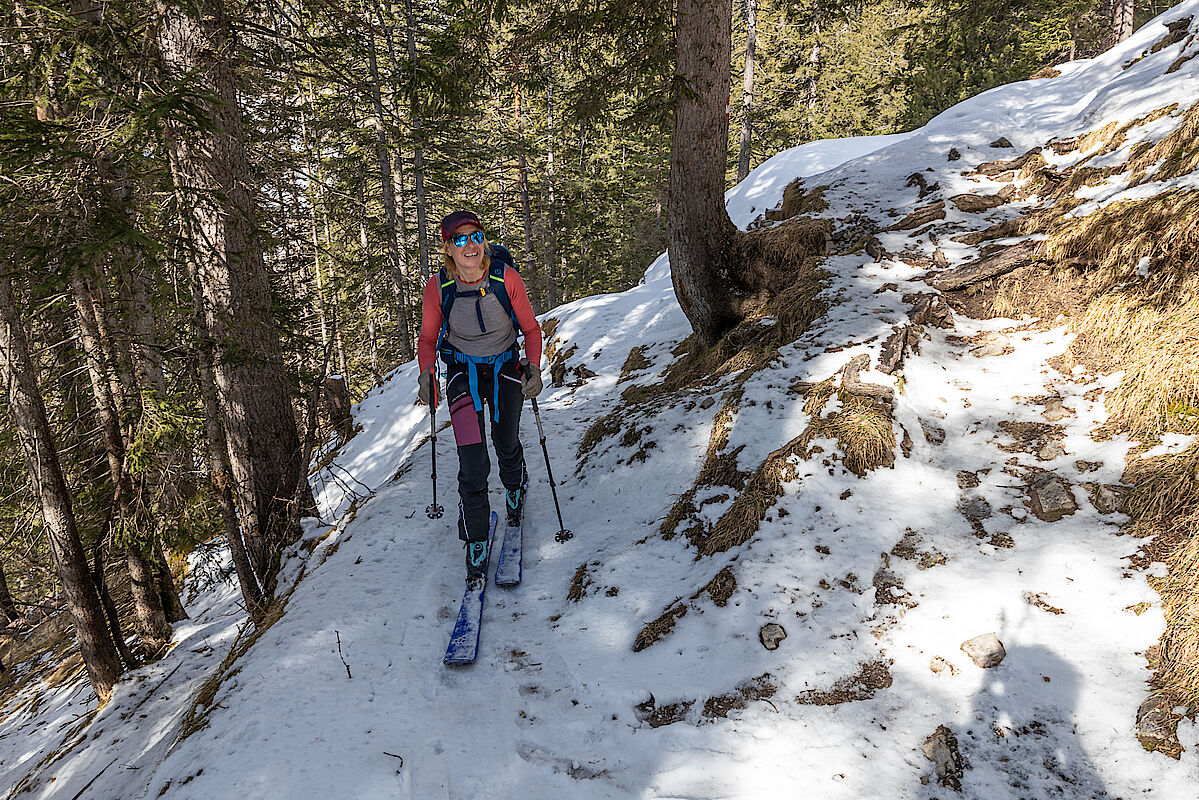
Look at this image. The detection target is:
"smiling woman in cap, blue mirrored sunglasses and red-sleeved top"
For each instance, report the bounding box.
[417,211,542,581]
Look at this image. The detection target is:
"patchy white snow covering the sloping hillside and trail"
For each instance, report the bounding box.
[7,0,1199,800]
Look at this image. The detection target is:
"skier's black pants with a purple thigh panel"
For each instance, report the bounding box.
[446,357,525,542]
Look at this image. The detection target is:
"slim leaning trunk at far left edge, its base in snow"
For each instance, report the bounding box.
[0,277,121,703]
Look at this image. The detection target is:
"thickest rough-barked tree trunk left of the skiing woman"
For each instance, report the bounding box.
[158,4,303,595]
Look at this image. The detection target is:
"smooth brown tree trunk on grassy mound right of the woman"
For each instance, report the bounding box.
[668,0,742,345]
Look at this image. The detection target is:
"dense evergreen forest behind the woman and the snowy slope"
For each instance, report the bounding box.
[0,0,1170,694]
